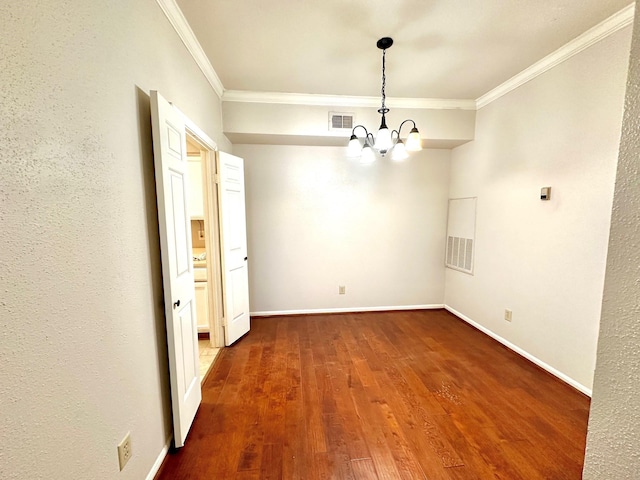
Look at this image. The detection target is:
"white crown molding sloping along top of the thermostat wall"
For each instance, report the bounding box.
[476,3,635,109]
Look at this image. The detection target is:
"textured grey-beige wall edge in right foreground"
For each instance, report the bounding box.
[584,4,640,480]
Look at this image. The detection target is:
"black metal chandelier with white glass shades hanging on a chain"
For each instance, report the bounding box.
[348,37,422,163]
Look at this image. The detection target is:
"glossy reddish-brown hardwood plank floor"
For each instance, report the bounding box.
[156,310,589,480]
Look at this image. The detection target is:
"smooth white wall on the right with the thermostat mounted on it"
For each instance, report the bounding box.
[445,27,631,391]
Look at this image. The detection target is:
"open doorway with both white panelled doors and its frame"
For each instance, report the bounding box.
[150,90,250,448]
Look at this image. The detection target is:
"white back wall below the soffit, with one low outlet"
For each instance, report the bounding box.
[233,145,450,312]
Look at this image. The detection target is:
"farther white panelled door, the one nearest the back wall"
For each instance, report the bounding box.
[218,152,250,346]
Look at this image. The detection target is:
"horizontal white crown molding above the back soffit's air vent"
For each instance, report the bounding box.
[222,90,476,110]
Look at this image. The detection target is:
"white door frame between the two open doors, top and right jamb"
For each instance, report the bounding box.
[181,111,225,347]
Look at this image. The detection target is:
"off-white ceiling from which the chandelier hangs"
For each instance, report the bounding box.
[177,0,630,99]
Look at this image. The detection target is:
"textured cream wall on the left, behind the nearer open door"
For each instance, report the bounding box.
[0,0,229,480]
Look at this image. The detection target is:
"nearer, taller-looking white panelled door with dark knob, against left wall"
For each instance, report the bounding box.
[151,91,202,447]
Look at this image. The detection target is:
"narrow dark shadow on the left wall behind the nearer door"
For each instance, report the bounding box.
[135,86,172,438]
